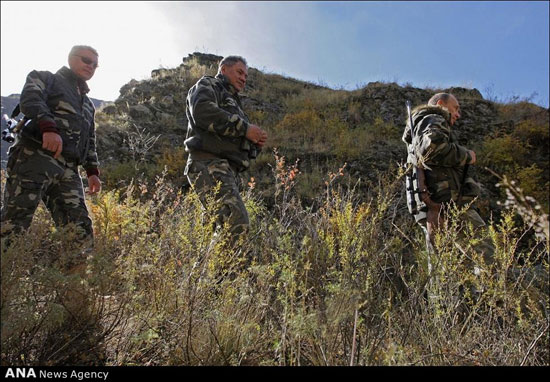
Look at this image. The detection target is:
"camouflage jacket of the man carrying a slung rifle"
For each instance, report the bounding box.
[402,105,480,204]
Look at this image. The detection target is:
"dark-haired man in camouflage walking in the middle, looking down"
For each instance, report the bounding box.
[185,56,267,238]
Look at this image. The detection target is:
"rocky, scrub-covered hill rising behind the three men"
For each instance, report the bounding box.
[2,53,550,215]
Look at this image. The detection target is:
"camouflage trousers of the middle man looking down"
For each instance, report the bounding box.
[185,159,249,239]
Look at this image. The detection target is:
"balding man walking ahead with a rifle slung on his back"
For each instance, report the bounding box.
[402,93,494,261]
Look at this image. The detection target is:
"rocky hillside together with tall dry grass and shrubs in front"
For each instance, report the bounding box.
[1,53,550,365]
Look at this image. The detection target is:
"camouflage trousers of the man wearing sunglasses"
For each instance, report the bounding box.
[1,144,93,241]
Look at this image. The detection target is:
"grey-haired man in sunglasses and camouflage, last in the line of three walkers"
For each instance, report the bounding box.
[2,45,101,240]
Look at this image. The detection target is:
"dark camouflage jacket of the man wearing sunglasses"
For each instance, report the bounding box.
[19,66,99,175]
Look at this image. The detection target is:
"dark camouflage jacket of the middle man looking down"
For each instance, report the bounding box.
[185,74,258,171]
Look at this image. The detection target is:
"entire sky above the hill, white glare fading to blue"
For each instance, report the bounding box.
[1,1,549,107]
